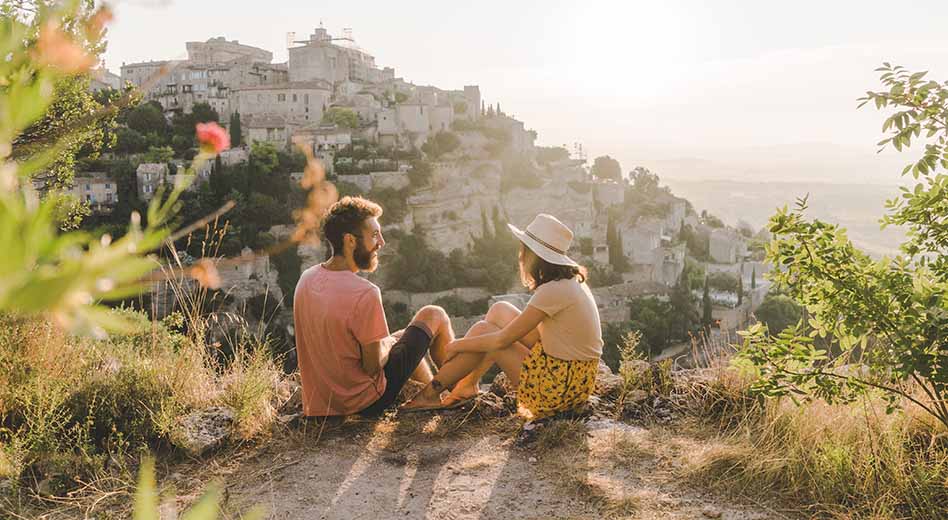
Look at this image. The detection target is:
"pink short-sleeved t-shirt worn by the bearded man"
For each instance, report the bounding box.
[293,265,389,416]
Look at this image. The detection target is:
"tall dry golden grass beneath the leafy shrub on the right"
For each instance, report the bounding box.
[685,360,948,520]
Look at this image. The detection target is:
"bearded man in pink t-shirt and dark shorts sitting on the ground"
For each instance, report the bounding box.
[293,197,454,417]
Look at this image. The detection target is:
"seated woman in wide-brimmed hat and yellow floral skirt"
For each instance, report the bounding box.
[403,214,602,420]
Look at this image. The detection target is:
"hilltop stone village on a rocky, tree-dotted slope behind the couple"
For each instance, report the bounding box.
[76,27,768,357]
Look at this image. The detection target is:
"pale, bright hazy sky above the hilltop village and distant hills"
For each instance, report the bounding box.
[105,0,948,179]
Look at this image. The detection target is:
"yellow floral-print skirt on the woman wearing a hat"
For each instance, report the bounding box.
[517,341,599,420]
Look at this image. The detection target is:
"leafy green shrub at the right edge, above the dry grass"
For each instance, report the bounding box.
[743,63,948,426]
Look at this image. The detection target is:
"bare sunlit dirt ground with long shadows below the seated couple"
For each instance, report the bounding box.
[200,413,785,520]
